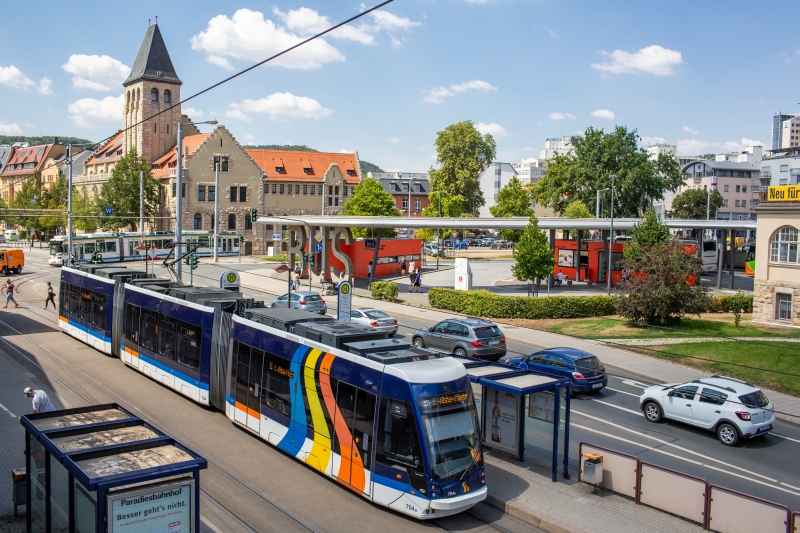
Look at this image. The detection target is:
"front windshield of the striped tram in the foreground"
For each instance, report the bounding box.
[419,390,480,481]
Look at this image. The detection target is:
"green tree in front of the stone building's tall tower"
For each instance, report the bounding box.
[96,150,159,231]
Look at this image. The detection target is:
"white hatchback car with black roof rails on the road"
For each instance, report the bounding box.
[639,376,775,446]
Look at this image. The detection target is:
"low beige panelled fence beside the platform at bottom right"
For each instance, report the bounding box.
[578,442,800,533]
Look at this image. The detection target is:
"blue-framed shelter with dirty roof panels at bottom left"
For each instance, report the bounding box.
[20,404,208,533]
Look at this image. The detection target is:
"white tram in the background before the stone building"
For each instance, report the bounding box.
[49,231,240,266]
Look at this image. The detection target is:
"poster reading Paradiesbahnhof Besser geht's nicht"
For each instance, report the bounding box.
[108,481,193,533]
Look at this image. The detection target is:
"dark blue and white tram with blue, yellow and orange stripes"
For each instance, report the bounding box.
[59,265,487,519]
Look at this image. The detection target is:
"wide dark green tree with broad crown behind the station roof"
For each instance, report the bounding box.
[532,126,684,218]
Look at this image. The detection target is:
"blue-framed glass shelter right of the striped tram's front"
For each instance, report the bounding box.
[451,356,571,482]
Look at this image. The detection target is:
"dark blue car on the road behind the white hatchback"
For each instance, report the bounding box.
[504,348,608,392]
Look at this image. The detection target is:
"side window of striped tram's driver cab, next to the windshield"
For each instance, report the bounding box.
[375,396,424,477]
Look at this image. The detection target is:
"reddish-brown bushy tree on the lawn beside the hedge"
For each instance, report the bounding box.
[615,241,710,325]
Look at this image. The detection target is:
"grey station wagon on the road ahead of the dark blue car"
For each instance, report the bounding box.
[411,318,506,361]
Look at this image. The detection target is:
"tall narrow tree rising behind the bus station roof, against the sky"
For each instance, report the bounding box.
[429,120,497,216]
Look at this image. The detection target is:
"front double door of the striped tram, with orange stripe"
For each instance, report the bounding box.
[334,381,376,495]
